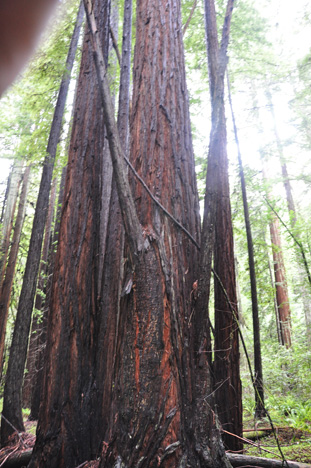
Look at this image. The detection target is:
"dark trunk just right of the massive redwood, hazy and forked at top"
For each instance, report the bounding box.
[197,0,243,450]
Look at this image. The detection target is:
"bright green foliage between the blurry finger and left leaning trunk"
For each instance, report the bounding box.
[0,2,81,164]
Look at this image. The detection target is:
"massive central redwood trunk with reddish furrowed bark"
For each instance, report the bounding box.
[101,0,202,467]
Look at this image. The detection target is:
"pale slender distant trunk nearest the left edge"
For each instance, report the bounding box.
[0,161,23,287]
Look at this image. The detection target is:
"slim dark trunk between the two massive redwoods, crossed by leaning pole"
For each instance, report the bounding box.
[96,0,132,440]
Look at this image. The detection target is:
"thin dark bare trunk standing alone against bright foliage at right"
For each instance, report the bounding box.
[227,74,266,419]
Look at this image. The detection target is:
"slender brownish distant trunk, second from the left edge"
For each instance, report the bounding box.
[0,166,30,375]
